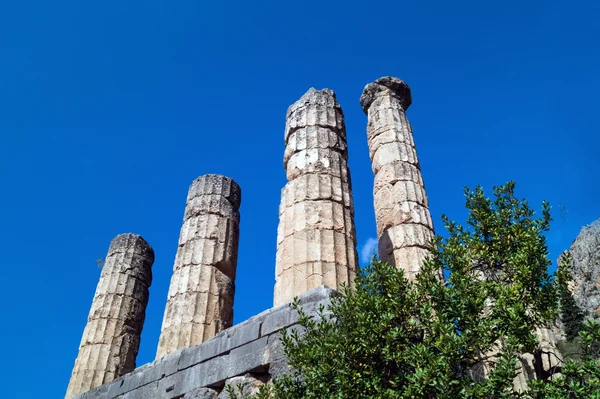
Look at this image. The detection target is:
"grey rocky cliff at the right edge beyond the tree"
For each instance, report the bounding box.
[570,219,600,319]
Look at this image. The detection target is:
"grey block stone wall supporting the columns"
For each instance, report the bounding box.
[74,287,337,399]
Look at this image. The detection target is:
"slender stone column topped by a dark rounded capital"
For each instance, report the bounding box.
[360,76,434,279]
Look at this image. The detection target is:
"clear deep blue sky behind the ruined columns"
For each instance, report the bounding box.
[0,0,600,398]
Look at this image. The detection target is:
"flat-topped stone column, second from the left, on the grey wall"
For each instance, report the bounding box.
[156,175,242,359]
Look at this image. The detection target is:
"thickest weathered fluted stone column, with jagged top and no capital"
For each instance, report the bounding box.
[273,88,358,305]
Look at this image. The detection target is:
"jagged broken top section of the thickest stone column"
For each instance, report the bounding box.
[285,87,345,143]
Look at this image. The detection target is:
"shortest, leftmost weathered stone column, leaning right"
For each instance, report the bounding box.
[66,234,154,398]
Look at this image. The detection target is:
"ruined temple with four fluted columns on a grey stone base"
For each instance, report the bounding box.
[66,77,560,399]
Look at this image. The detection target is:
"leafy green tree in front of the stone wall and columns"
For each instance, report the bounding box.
[238,182,597,399]
